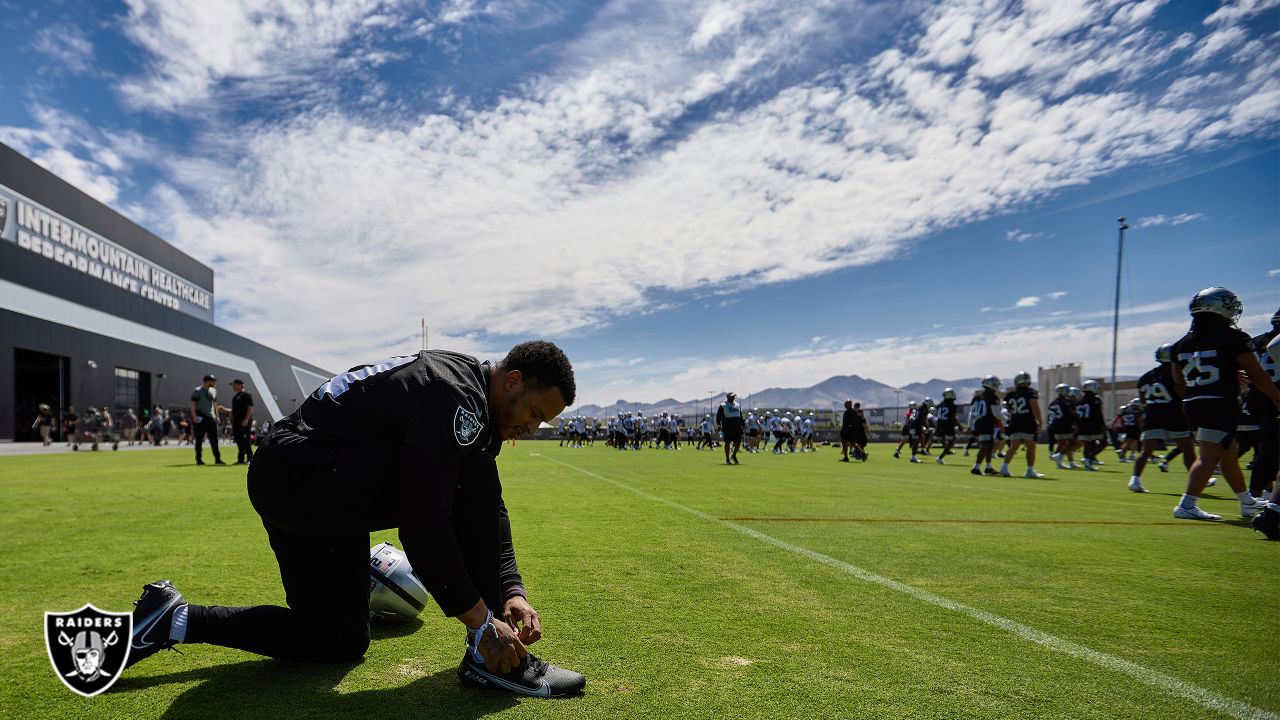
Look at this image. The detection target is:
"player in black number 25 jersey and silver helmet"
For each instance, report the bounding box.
[1172,287,1280,520]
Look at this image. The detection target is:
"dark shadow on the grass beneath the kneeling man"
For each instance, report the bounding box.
[115,659,517,720]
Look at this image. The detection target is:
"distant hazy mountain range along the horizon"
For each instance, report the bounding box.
[571,375,1135,418]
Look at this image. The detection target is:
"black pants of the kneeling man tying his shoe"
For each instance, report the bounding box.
[186,448,503,662]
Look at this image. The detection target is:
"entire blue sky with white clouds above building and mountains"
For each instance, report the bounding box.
[0,0,1280,405]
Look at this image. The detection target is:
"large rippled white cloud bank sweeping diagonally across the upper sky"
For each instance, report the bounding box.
[22,0,1280,368]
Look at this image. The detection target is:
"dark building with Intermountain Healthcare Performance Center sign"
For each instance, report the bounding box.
[0,143,332,441]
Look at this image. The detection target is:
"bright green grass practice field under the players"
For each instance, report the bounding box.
[0,442,1280,720]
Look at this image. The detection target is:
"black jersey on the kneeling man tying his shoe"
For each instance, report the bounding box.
[282,350,500,461]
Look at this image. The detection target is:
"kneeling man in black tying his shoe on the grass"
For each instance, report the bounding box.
[129,341,585,696]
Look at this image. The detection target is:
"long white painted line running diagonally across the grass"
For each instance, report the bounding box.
[530,452,1280,720]
